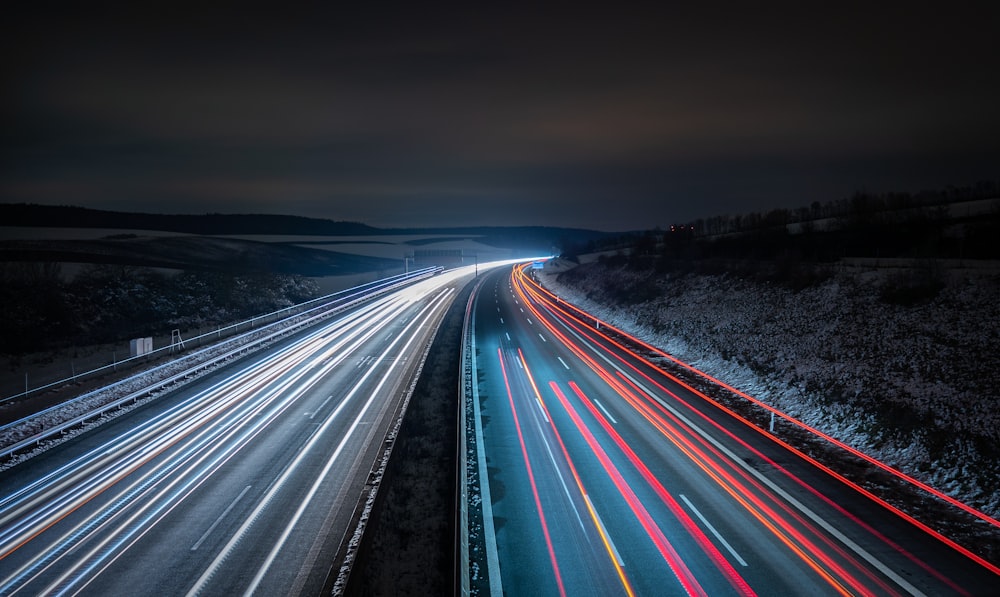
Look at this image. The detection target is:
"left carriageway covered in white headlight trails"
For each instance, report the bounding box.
[0,266,482,595]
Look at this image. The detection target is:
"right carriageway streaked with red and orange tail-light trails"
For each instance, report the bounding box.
[472,267,1000,596]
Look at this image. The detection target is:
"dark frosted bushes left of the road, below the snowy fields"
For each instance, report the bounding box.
[0,263,318,355]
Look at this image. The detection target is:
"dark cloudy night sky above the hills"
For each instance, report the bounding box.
[0,2,1000,231]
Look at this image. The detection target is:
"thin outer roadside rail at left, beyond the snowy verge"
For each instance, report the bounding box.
[0,266,443,406]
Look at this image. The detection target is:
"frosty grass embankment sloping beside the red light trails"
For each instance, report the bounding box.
[539,261,1000,518]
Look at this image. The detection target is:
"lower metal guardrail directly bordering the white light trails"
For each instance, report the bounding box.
[0,267,442,457]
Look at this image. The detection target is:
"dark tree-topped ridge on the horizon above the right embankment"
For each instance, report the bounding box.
[564,182,1000,263]
